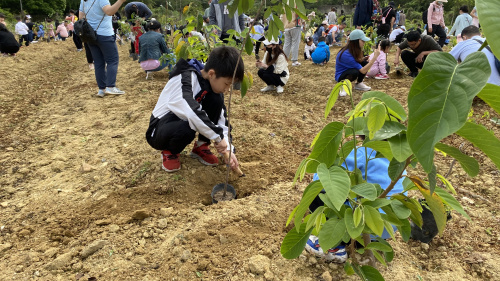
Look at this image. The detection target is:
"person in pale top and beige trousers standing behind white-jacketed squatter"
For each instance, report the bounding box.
[280,9,302,66]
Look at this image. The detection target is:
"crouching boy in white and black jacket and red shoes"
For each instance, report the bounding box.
[146,46,244,172]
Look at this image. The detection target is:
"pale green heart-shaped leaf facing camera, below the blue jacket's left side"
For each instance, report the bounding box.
[317,163,351,210]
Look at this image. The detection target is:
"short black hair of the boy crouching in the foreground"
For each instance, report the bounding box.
[204,46,245,82]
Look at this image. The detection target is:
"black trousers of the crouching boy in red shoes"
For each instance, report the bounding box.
[146,93,225,154]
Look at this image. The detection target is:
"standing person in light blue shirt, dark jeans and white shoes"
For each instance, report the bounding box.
[79,0,125,98]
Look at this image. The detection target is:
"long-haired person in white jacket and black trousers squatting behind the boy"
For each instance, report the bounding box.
[255,39,290,93]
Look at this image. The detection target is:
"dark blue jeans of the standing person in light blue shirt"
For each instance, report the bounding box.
[88,35,119,90]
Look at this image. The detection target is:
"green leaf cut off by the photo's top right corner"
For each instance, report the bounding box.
[476,0,500,58]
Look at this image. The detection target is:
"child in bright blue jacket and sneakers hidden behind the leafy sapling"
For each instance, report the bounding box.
[306,143,406,263]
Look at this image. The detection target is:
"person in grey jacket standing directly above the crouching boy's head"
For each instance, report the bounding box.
[209,0,245,43]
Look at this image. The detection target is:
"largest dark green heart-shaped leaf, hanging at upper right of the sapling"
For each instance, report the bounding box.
[408,52,491,173]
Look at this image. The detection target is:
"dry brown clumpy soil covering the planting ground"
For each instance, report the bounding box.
[0,41,500,281]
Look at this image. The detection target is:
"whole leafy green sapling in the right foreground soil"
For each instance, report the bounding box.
[281,0,500,280]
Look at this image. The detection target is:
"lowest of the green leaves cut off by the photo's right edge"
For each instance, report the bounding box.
[457,122,500,169]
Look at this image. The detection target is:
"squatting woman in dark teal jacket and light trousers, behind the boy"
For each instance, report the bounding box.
[139,20,170,72]
